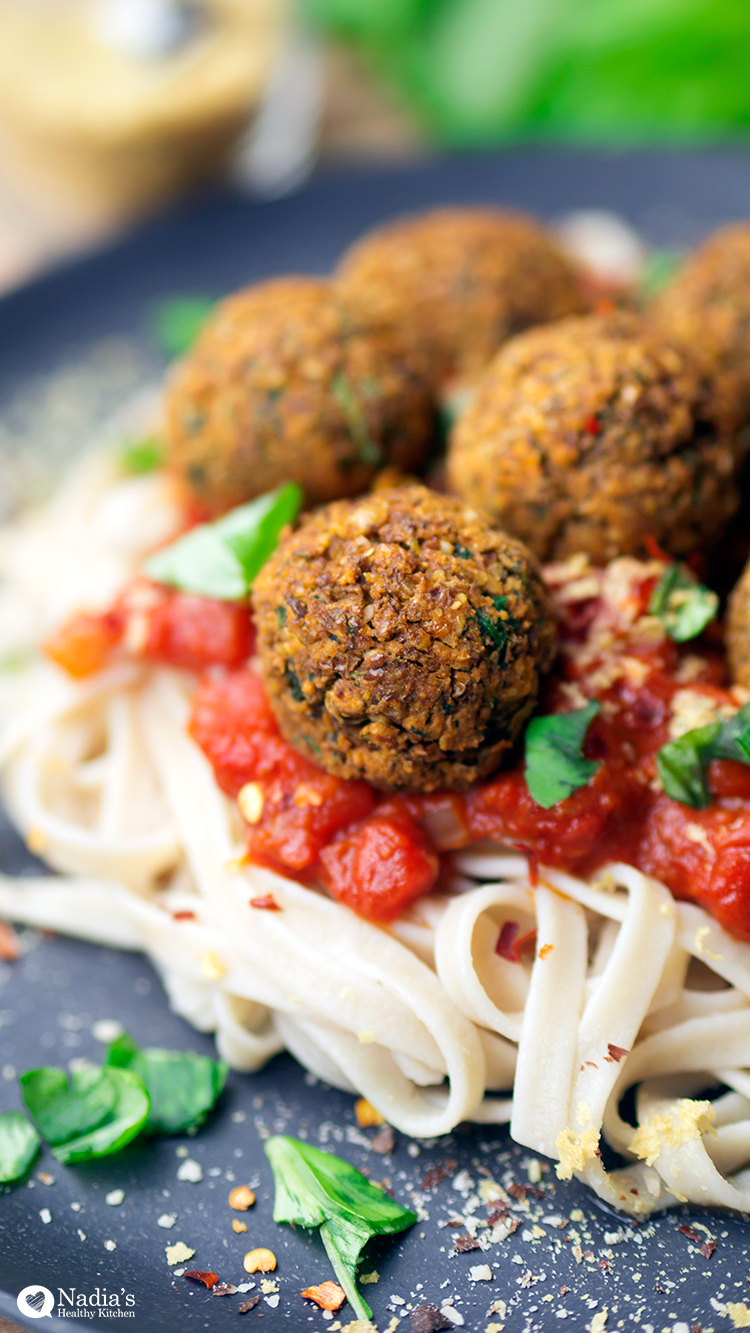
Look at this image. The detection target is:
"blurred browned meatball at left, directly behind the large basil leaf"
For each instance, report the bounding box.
[167,277,433,513]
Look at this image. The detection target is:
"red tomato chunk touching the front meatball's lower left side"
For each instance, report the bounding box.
[189,670,288,796]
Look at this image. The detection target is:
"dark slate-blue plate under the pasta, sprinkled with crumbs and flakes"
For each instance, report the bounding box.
[0,151,750,1333]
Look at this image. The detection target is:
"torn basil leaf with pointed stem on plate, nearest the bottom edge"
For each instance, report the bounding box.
[265,1136,417,1320]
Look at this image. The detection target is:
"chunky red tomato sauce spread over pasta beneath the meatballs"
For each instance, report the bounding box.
[48,560,750,940]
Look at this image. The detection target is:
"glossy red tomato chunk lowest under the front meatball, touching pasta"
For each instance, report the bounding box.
[320,812,440,921]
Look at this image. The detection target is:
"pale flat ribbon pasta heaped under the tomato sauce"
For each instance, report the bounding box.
[0,463,750,1214]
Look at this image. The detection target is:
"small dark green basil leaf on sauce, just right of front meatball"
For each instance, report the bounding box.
[524,700,602,810]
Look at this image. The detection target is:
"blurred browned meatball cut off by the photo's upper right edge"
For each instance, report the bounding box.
[647,223,750,429]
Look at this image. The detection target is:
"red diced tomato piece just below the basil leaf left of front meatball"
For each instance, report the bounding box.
[143,592,254,670]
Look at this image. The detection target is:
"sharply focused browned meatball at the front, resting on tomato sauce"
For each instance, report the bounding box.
[253,484,556,792]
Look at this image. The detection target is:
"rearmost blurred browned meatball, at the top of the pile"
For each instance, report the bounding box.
[338,208,585,381]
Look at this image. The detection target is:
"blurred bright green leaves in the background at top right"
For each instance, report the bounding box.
[301,0,750,147]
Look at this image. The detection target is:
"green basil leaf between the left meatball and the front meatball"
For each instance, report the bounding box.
[144,481,302,601]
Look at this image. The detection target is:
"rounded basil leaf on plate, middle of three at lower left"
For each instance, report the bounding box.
[19,1065,148,1162]
